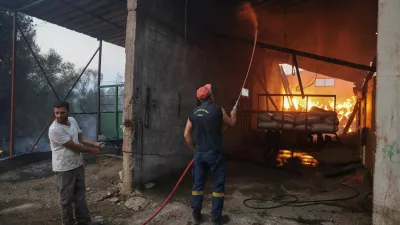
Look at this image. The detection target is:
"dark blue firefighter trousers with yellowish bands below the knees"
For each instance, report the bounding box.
[192,150,225,221]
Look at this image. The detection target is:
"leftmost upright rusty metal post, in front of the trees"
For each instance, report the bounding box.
[10,11,17,157]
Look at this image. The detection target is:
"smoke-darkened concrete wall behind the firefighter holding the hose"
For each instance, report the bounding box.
[133,0,255,184]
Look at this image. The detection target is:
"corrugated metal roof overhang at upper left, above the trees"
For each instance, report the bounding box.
[0,0,127,47]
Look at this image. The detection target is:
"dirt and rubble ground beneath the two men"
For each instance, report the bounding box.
[0,151,371,225]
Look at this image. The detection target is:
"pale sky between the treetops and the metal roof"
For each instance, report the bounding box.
[33,18,125,85]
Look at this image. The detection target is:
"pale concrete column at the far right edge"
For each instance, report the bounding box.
[373,0,400,225]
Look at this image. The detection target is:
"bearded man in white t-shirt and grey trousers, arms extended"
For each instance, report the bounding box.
[49,101,104,225]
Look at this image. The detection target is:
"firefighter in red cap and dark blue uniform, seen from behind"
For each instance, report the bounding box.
[184,84,237,225]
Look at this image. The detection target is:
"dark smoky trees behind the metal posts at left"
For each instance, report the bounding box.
[0,9,108,137]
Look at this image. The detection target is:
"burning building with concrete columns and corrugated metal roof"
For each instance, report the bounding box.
[0,0,400,224]
